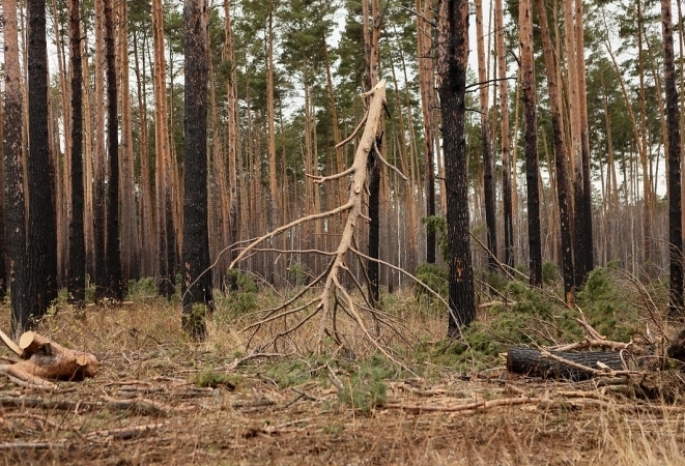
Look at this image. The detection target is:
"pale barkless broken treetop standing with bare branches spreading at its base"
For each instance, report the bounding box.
[229,80,406,354]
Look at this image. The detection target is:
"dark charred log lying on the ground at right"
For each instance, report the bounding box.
[507,346,625,381]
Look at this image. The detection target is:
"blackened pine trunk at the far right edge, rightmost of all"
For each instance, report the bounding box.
[661,0,684,317]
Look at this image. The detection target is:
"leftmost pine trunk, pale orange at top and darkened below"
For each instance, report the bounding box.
[2,0,30,338]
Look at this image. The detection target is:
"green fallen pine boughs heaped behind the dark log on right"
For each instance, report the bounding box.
[418,267,644,371]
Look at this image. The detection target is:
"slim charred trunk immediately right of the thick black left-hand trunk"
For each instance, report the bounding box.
[67,0,86,305]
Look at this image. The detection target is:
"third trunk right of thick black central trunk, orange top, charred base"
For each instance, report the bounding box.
[519,0,542,287]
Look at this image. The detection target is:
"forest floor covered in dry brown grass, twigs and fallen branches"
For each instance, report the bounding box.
[0,274,685,465]
